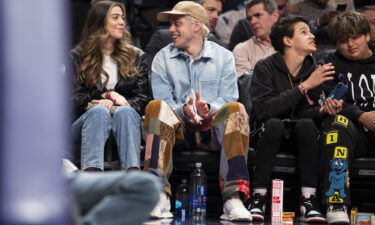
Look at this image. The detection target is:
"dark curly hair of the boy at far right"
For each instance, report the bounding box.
[328,11,370,42]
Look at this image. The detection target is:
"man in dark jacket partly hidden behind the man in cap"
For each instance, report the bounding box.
[145,0,227,70]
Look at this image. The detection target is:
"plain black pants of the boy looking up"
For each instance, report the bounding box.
[253,118,319,188]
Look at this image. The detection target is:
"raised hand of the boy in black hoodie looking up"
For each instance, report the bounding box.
[301,63,335,91]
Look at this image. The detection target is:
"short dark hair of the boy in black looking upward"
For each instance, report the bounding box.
[270,16,309,54]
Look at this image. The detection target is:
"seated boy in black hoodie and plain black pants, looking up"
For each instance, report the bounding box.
[250,16,342,223]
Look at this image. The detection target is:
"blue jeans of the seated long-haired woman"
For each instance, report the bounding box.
[73,106,141,170]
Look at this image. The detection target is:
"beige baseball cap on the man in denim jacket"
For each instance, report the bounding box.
[157,1,208,24]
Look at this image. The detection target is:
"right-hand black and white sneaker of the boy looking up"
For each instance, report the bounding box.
[300,195,326,223]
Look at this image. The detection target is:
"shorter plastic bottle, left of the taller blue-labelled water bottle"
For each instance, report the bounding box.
[175,179,189,221]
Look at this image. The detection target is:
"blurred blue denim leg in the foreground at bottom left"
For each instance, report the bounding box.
[68,171,160,225]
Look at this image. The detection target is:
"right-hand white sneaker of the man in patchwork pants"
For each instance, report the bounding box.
[220,198,253,221]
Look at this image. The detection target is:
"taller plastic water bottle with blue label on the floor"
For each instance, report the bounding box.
[189,162,207,222]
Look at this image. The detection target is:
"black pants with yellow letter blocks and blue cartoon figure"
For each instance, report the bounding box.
[320,115,375,204]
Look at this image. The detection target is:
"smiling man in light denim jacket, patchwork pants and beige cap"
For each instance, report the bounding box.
[144,1,252,221]
